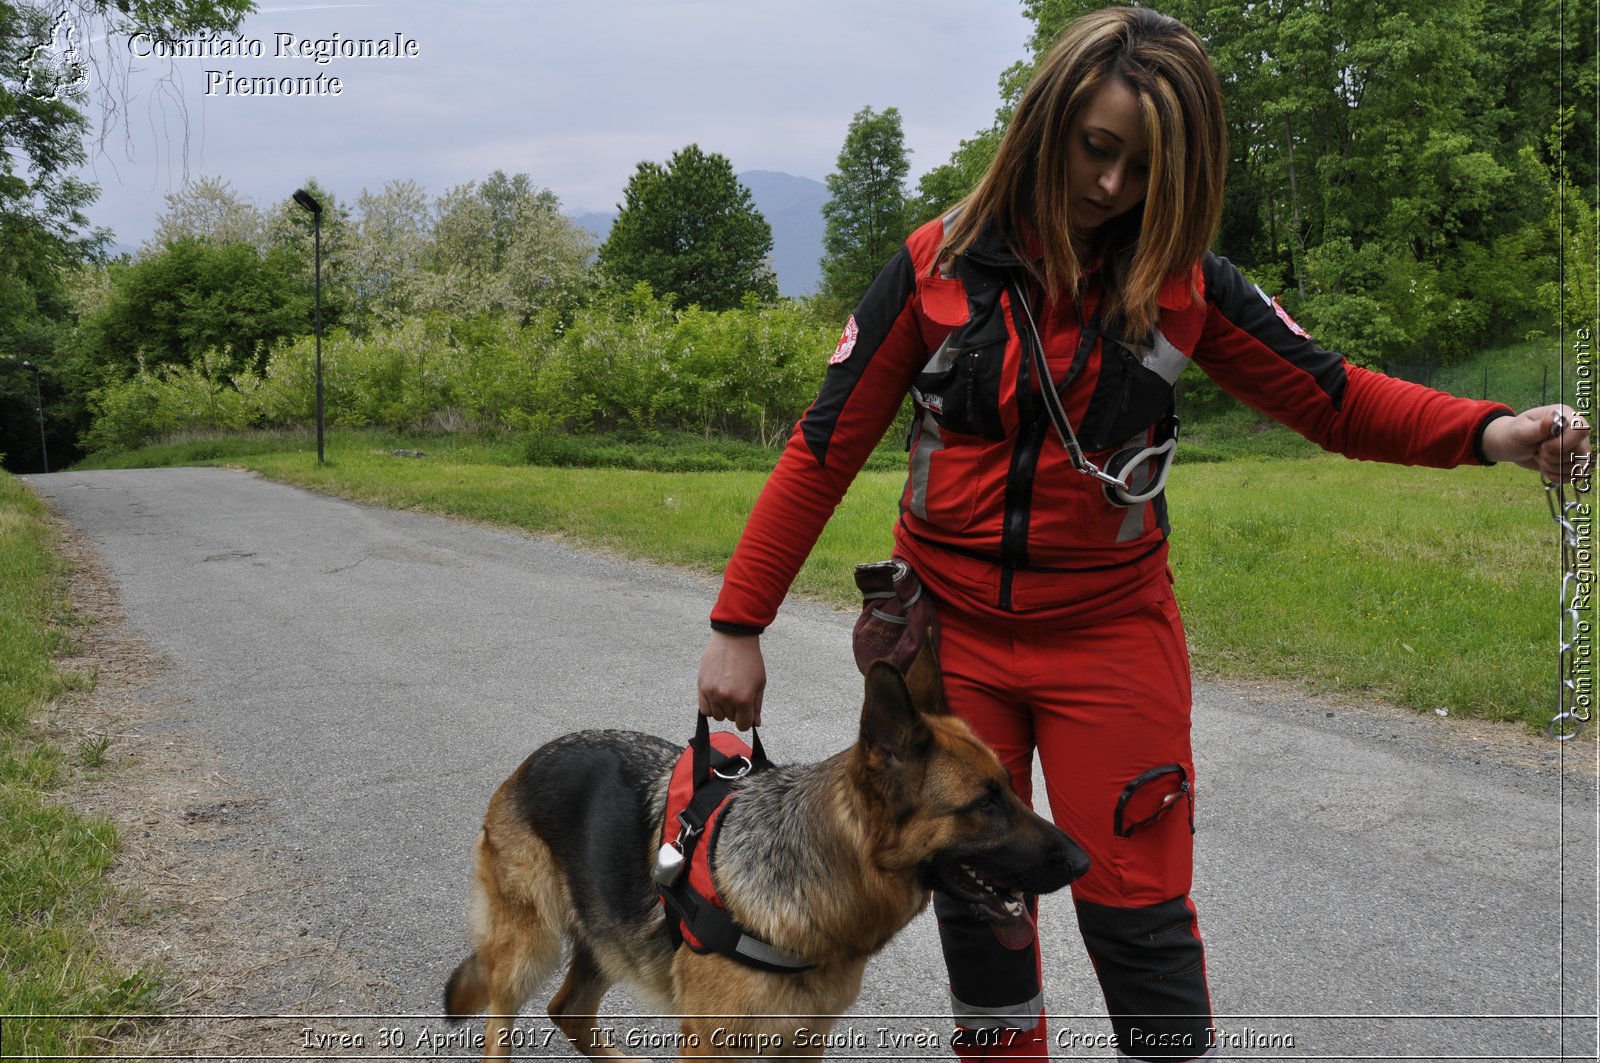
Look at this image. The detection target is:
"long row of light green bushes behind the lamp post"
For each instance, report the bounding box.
[79,285,837,450]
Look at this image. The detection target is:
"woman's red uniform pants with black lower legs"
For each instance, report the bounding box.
[934,585,1211,1060]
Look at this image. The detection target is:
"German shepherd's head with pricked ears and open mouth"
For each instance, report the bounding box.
[854,640,1090,929]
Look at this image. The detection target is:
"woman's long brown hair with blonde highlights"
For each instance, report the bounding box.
[941,8,1227,336]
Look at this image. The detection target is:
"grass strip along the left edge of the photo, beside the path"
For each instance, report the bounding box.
[0,475,152,1058]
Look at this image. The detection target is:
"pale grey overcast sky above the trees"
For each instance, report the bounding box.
[62,0,1030,247]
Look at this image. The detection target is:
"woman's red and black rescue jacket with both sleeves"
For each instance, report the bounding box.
[712,214,1512,632]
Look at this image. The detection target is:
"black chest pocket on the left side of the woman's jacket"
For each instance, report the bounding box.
[912,258,1011,440]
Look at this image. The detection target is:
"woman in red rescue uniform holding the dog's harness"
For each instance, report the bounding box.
[699,8,1589,1060]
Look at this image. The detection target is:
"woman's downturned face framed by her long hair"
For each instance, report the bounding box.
[1067,77,1150,234]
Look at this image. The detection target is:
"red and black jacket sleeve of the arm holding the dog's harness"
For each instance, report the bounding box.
[710,223,965,634]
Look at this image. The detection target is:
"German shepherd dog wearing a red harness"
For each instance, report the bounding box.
[445,644,1088,1060]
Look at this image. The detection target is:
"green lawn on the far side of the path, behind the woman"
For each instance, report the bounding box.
[78,432,1560,727]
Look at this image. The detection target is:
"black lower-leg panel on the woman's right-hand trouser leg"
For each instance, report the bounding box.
[1077,897,1211,1060]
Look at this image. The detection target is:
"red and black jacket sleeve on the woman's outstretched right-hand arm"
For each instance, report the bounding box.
[1194,256,1512,467]
